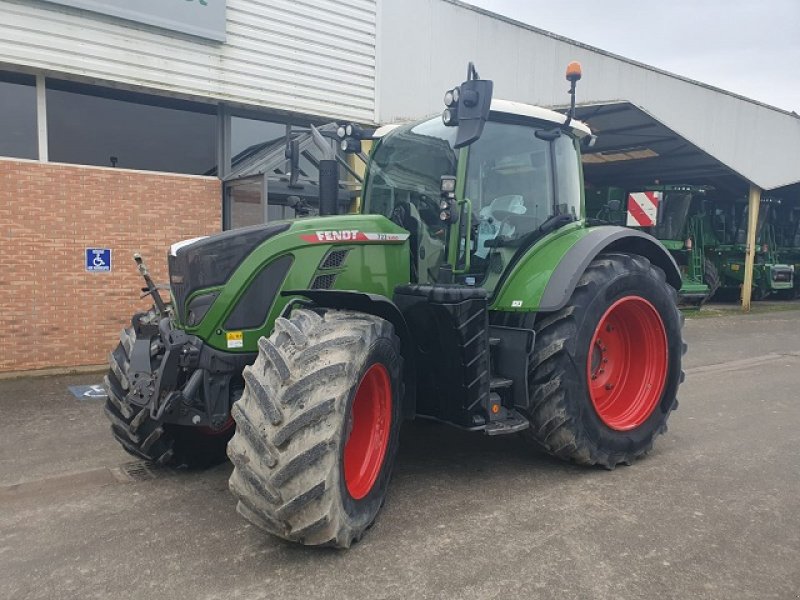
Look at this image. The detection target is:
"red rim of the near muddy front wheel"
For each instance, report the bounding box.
[344,364,392,500]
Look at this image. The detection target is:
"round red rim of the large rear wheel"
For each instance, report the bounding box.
[587,296,668,431]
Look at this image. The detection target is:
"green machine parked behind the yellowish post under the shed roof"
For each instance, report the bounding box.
[705,197,794,300]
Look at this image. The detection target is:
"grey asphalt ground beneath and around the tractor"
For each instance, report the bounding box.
[0,310,800,600]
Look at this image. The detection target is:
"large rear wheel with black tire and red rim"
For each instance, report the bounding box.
[524,253,686,469]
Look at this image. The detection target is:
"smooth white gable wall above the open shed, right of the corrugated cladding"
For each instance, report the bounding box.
[377,0,800,189]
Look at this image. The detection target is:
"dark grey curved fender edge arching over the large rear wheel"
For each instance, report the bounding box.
[539,225,682,312]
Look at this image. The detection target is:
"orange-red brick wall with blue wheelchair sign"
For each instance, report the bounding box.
[0,159,221,372]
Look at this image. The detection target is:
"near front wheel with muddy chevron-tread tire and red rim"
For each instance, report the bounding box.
[228,310,402,548]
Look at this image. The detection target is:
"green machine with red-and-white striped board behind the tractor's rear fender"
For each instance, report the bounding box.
[586,185,720,306]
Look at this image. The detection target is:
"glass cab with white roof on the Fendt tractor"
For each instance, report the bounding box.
[364,99,590,290]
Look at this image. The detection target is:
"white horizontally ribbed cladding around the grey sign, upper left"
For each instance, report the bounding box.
[0,0,377,122]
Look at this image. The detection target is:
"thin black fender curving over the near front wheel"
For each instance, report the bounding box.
[281,290,417,419]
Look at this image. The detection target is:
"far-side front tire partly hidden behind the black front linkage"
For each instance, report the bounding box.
[104,327,233,468]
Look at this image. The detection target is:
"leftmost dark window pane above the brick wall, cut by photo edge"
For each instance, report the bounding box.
[0,71,39,159]
